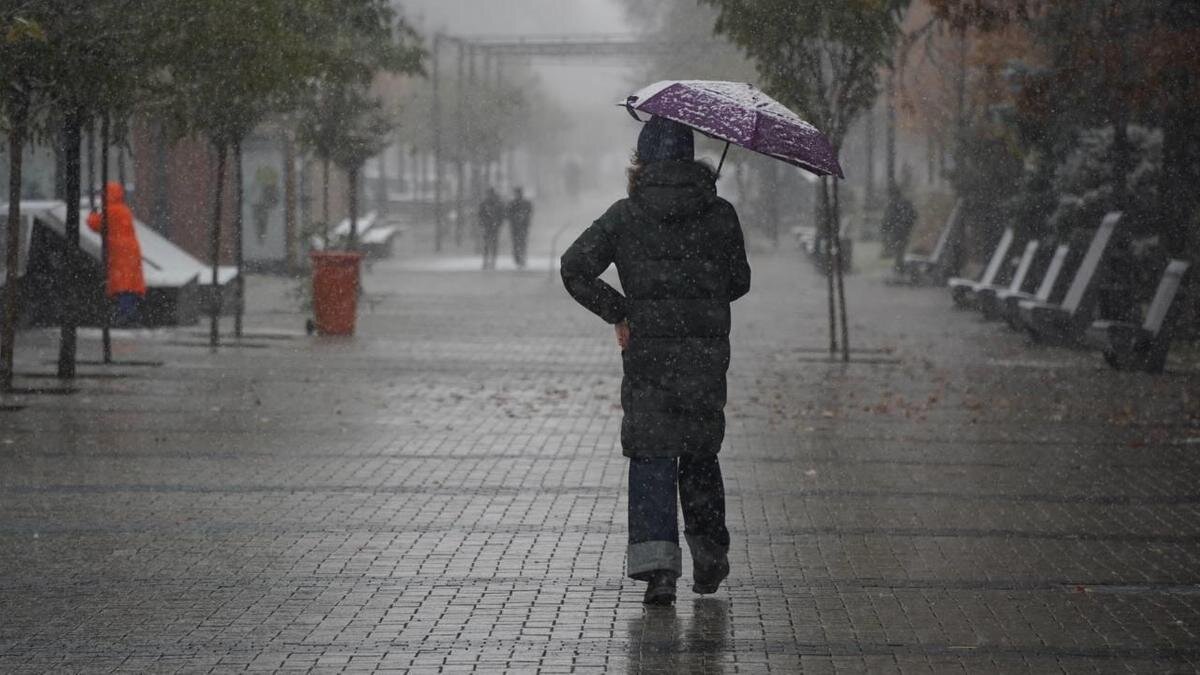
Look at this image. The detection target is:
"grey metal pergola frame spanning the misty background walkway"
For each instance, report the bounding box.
[430,34,678,251]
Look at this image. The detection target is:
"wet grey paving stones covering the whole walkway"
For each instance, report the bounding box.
[0,243,1200,673]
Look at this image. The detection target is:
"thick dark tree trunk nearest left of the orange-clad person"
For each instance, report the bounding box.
[59,108,85,380]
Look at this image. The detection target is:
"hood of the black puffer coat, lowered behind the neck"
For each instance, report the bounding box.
[630,160,716,220]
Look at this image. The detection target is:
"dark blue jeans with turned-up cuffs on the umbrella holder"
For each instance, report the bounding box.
[625,455,730,581]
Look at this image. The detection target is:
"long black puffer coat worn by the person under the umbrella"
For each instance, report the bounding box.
[562,161,750,458]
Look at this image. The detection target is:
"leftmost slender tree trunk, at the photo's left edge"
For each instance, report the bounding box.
[0,90,29,392]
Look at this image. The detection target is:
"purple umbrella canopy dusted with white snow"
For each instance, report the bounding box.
[620,79,845,178]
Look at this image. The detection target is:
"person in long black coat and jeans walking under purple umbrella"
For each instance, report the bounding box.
[562,118,750,604]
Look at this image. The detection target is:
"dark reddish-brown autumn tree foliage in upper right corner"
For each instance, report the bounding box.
[930,0,1200,263]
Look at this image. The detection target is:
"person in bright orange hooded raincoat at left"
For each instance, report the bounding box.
[88,183,146,325]
